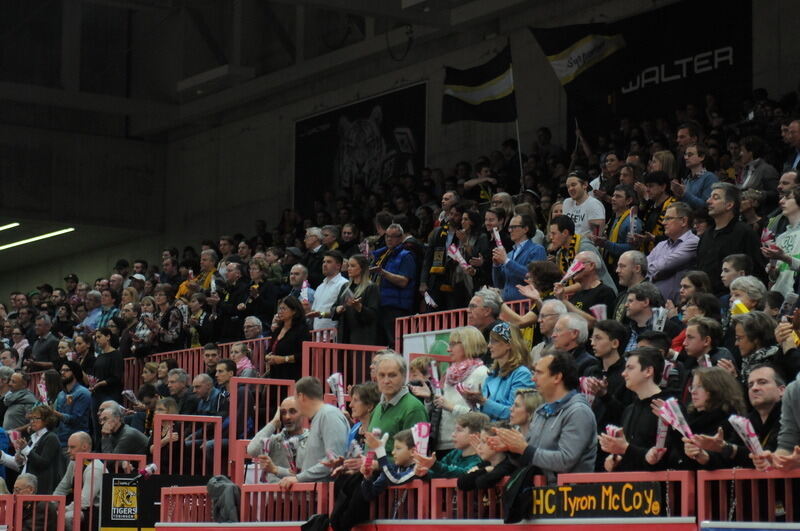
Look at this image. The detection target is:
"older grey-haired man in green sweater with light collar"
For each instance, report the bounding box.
[369,352,428,455]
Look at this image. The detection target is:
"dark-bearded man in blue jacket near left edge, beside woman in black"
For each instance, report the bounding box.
[55,360,92,448]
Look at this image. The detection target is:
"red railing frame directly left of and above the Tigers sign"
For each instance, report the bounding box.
[72,453,147,529]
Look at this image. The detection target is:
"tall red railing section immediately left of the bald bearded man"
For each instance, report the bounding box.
[228,378,294,485]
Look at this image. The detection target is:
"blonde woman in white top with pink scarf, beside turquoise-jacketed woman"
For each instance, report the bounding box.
[433,326,489,451]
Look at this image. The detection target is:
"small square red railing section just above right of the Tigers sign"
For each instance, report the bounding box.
[152,414,224,476]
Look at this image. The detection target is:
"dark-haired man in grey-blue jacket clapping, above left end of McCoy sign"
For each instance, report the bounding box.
[492,351,597,485]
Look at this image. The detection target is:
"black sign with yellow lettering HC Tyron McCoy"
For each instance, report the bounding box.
[531,482,665,518]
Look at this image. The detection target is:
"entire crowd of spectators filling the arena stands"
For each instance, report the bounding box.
[0,87,800,529]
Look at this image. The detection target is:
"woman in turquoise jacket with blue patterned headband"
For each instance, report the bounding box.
[463,321,531,420]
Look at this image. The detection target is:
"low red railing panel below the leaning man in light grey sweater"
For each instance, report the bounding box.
[239,483,328,522]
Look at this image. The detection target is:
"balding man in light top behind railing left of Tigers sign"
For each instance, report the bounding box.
[53,431,105,531]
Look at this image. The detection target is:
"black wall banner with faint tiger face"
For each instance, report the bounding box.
[295,83,426,214]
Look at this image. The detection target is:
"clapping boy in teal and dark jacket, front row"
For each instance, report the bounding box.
[414,411,490,479]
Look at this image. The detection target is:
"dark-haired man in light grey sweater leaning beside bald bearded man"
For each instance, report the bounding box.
[279,376,350,490]
